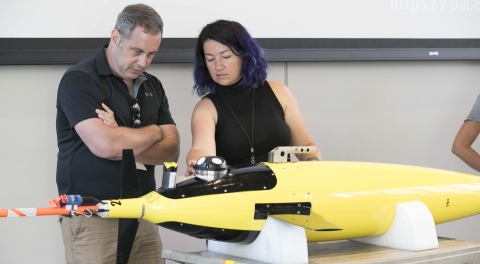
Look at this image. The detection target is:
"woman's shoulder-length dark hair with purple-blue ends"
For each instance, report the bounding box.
[193,20,268,96]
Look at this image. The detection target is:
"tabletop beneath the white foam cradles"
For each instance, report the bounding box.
[162,237,480,264]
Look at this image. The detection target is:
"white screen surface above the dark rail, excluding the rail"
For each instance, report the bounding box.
[0,0,480,39]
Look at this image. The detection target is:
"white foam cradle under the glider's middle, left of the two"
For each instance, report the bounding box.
[208,217,308,263]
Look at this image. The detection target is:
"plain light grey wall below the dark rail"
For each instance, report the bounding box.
[0,61,480,264]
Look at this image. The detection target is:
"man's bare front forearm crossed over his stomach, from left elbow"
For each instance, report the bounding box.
[75,118,163,160]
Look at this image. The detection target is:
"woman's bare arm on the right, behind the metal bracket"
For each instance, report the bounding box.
[268,81,321,160]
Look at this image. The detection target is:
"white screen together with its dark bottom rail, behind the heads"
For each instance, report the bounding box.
[0,0,480,65]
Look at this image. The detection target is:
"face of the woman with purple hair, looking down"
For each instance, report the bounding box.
[203,39,242,86]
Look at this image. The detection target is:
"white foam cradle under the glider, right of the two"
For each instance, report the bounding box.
[353,201,438,251]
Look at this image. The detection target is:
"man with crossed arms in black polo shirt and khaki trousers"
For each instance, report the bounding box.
[57,4,179,263]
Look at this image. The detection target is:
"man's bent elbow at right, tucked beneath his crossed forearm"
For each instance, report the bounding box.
[135,124,180,165]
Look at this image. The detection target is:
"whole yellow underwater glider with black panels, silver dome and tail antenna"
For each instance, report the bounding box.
[0,147,480,256]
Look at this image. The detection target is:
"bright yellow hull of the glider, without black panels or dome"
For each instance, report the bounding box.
[104,161,480,242]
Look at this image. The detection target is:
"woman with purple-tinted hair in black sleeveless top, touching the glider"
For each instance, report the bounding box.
[186,20,320,175]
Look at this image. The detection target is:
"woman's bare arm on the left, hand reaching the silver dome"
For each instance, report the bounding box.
[185,98,217,176]
